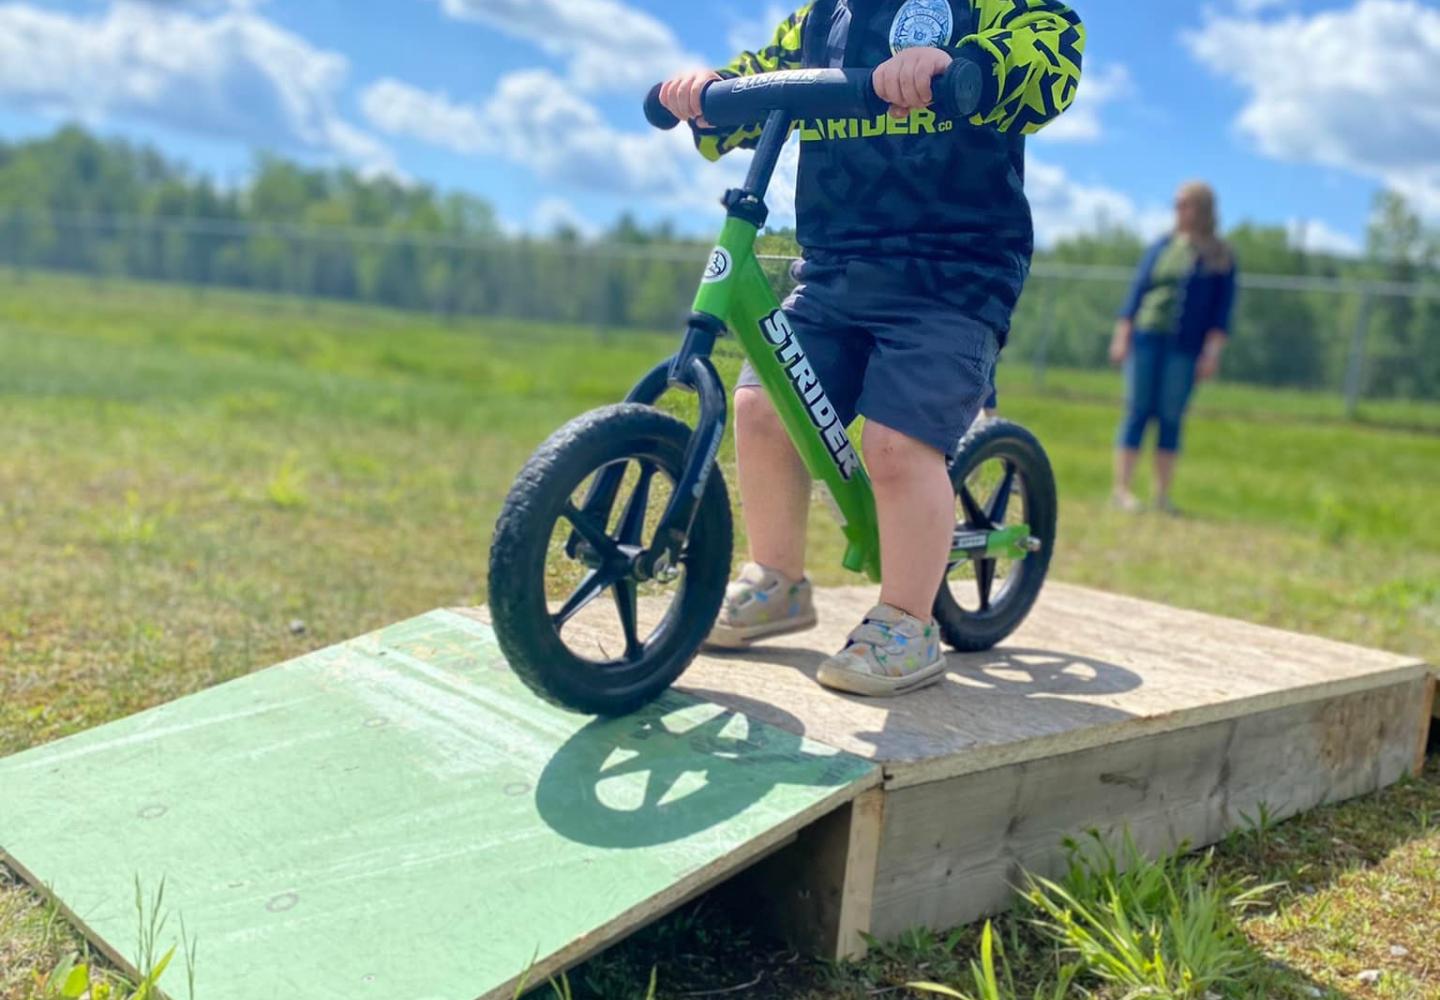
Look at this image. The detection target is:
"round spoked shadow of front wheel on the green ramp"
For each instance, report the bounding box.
[536,687,874,849]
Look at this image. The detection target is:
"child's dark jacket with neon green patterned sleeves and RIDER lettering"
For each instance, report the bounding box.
[696,0,1084,327]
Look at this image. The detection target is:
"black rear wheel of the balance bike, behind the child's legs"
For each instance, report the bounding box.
[935,419,1057,653]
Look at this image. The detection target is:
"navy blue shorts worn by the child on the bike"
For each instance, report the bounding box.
[739,261,999,458]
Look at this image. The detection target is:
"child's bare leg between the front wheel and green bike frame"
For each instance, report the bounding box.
[734,386,811,579]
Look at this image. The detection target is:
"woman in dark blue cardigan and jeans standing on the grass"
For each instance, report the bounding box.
[1110,182,1236,513]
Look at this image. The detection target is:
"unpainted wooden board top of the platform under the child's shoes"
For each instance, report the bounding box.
[463,582,1426,787]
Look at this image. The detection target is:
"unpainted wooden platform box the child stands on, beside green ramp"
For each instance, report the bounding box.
[668,585,1434,955]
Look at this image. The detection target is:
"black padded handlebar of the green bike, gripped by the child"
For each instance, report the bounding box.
[645,59,985,131]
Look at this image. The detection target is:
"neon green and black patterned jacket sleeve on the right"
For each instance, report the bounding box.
[956,0,1084,135]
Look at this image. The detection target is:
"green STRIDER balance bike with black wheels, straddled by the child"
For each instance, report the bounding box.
[490,63,1057,716]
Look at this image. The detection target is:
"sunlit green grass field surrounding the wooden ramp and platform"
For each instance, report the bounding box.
[0,274,1440,1000]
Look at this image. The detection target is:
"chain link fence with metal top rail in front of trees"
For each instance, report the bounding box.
[8,212,1440,412]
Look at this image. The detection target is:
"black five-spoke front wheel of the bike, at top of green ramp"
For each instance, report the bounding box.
[490,403,732,715]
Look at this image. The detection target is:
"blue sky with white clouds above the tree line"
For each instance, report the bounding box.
[0,0,1440,249]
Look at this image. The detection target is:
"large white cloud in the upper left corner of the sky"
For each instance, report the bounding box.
[0,0,393,170]
